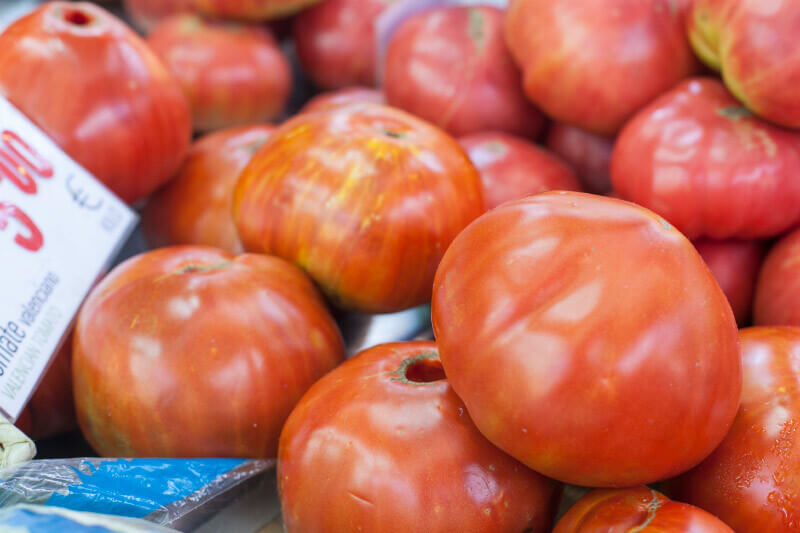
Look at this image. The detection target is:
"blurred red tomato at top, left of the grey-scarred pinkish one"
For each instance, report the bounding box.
[292,0,397,89]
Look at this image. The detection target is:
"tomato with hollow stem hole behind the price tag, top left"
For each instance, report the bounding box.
[0,2,191,202]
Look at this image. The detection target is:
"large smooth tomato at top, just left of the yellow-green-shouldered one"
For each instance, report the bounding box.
[506,0,698,135]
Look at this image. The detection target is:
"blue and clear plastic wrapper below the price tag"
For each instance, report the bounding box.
[0,458,274,531]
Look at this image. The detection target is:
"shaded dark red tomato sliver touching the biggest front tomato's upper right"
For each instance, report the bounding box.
[694,239,765,326]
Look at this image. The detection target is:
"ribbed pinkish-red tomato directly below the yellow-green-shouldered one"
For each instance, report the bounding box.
[611,78,800,239]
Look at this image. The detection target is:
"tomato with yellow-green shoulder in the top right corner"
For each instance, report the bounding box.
[688,0,800,128]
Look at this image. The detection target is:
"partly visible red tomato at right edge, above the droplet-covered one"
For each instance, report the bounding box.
[753,229,800,326]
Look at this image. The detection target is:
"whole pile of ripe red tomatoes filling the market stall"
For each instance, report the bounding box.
[0,0,800,533]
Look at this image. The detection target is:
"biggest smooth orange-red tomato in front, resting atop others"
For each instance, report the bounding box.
[432,192,741,487]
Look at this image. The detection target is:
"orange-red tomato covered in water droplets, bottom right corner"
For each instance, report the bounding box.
[676,326,800,533]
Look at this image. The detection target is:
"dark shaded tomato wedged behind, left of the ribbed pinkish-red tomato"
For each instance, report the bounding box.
[546,122,614,194]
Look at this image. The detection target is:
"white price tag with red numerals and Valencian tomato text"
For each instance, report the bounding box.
[0,98,137,420]
